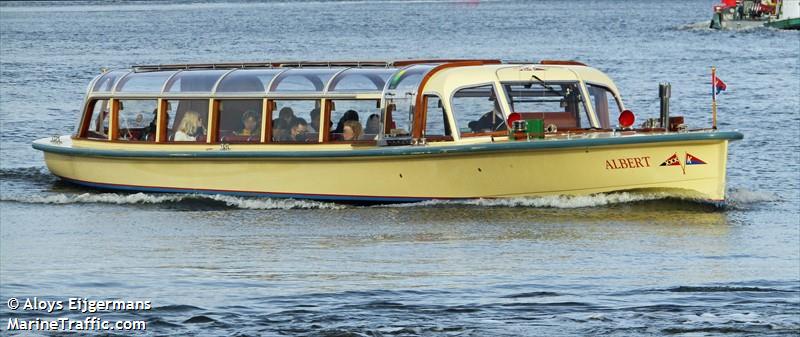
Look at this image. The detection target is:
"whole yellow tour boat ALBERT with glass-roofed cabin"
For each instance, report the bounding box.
[33,60,743,203]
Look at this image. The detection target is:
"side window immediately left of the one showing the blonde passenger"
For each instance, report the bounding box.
[117,99,158,142]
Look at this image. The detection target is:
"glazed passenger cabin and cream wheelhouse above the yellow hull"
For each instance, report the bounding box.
[73,60,624,146]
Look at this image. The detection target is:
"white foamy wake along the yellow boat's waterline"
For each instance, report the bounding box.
[0,167,780,210]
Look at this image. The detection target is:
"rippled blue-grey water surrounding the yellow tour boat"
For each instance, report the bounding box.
[0,1,800,336]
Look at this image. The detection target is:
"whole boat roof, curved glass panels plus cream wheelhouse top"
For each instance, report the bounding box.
[88,59,616,97]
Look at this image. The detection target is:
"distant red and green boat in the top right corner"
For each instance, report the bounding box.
[710,0,800,29]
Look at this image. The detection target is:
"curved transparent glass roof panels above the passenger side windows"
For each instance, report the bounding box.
[89,64,422,96]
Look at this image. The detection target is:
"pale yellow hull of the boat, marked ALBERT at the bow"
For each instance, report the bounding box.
[34,133,741,202]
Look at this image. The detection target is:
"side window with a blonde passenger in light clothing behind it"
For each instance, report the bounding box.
[167,99,208,143]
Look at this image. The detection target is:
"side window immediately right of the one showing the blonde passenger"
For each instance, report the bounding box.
[216,99,264,143]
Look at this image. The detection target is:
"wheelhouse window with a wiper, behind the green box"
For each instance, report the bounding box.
[504,82,592,130]
